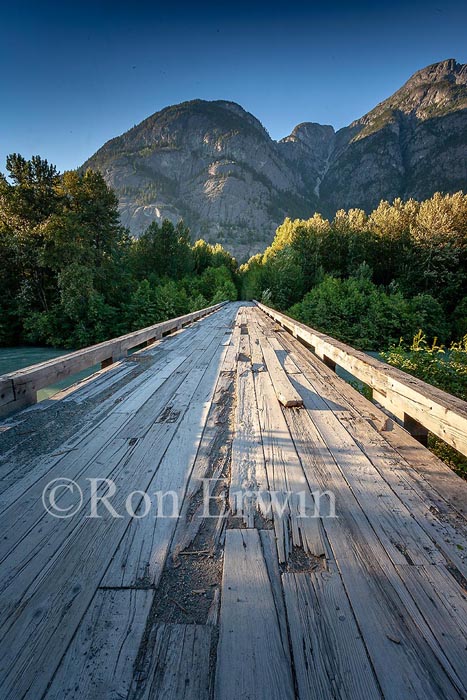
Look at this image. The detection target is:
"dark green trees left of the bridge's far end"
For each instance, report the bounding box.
[0,154,238,348]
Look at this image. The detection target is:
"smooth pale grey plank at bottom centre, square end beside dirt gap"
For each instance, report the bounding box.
[215,529,295,700]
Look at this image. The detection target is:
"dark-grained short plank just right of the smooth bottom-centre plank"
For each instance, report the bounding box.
[282,562,381,700]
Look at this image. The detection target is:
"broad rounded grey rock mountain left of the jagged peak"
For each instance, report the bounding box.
[83,100,318,257]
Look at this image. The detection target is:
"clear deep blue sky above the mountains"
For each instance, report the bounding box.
[0,0,467,170]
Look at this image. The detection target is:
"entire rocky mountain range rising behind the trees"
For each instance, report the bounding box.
[83,59,467,259]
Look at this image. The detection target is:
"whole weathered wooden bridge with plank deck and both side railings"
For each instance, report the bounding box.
[0,303,467,700]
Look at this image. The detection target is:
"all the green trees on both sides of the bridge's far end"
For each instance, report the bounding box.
[0,154,467,351]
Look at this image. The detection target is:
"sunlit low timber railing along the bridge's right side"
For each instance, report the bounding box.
[255,302,467,455]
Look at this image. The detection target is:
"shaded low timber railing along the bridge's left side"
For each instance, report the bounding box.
[0,302,225,416]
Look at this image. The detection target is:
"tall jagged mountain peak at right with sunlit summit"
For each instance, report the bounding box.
[320,59,467,214]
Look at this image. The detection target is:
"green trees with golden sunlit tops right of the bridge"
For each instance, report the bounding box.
[240,192,467,350]
